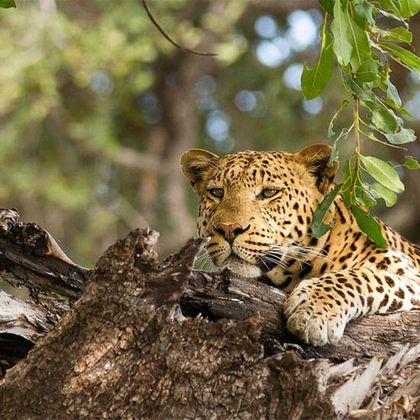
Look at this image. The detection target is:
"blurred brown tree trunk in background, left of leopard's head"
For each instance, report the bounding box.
[146,0,223,250]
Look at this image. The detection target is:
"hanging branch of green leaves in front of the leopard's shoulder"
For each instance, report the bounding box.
[301,0,420,247]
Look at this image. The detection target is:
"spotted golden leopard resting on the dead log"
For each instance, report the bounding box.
[180,144,420,346]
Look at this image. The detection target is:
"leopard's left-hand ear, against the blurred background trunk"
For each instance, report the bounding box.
[180,149,219,187]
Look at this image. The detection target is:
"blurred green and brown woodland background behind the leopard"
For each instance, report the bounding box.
[0,0,420,266]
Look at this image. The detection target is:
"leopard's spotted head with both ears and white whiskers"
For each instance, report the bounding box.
[181,145,338,277]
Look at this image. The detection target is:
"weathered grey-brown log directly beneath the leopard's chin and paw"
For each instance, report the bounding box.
[181,272,420,360]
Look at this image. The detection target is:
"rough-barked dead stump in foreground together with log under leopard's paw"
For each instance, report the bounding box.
[0,210,420,419]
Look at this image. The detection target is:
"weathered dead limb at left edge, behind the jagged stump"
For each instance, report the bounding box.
[0,209,89,370]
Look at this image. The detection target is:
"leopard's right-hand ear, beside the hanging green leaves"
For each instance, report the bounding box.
[295,144,338,194]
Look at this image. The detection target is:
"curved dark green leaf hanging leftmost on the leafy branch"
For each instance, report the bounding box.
[301,20,334,99]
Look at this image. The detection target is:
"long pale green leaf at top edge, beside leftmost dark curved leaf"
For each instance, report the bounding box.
[331,0,353,66]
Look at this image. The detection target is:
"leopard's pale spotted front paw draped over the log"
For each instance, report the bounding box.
[284,280,347,346]
